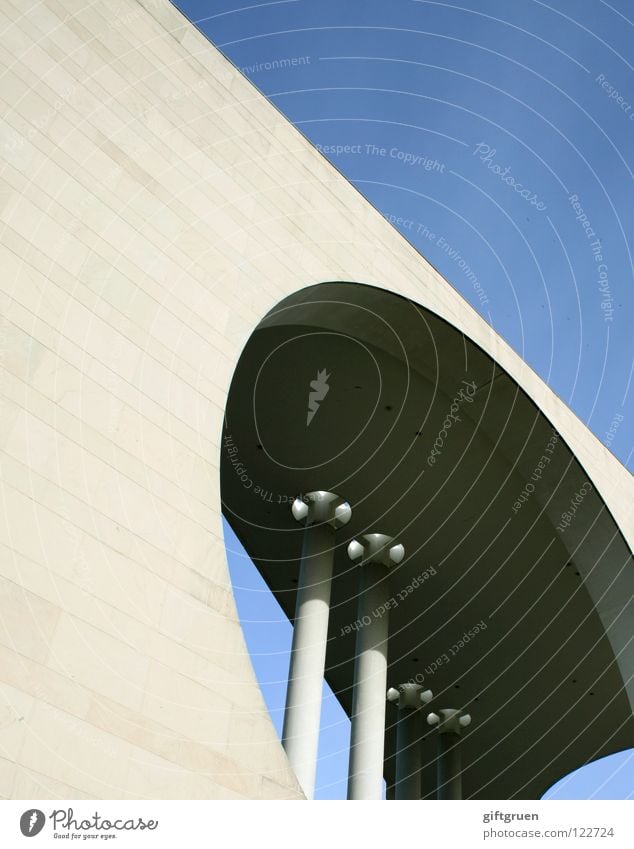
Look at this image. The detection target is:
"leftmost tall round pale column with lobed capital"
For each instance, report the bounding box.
[282,491,352,799]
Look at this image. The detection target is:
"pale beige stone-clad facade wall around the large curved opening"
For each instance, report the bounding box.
[0,0,634,798]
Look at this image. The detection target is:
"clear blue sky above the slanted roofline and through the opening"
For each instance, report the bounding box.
[170,0,634,798]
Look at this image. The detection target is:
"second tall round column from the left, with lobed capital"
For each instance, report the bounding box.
[348,534,405,799]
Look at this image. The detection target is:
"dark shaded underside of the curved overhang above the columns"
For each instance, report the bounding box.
[221,282,634,799]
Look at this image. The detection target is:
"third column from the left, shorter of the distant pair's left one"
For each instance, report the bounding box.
[387,682,432,800]
